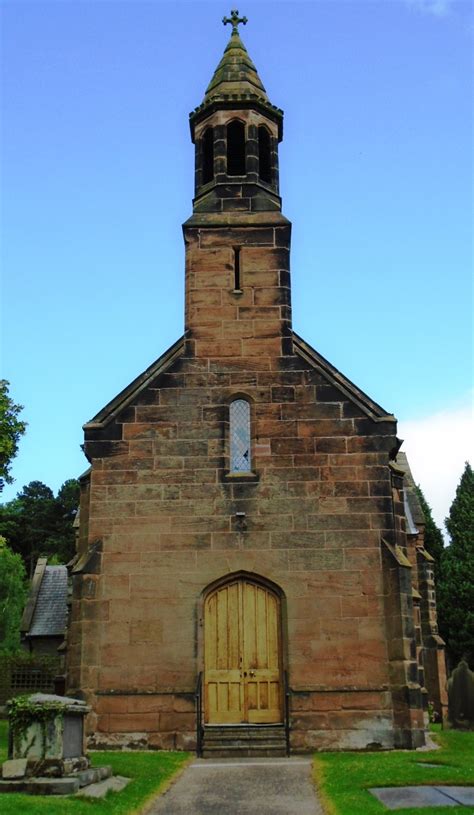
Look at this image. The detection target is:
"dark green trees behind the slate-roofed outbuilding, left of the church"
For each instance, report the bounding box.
[0,478,79,577]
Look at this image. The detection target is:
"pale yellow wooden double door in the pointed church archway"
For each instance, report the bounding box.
[204,579,283,724]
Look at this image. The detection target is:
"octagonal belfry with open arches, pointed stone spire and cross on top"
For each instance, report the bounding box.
[189,9,283,217]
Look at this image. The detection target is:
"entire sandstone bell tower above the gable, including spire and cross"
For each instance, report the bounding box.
[183,10,292,358]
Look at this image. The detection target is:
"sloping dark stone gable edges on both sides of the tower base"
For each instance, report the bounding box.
[83,332,396,430]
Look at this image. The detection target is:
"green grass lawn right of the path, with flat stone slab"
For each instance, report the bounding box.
[314,725,474,815]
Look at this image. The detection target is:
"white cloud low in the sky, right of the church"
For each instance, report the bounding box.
[398,397,474,534]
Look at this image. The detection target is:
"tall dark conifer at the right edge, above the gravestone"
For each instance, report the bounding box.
[438,462,474,668]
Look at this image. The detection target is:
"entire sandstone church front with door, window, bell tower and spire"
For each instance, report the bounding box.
[67,19,445,754]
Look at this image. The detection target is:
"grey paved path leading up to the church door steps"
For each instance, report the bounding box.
[148,758,323,815]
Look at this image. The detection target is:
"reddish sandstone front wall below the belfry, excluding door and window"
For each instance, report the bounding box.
[69,222,417,750]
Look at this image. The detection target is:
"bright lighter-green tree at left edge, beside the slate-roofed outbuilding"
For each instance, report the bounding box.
[0,536,27,653]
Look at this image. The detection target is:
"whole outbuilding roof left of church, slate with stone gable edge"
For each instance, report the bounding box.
[21,558,68,637]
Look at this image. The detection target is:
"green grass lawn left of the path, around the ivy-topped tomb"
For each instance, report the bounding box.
[0,721,189,815]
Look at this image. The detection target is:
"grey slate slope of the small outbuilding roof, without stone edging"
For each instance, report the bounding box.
[28,566,68,637]
